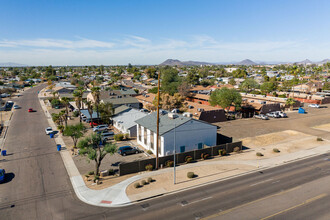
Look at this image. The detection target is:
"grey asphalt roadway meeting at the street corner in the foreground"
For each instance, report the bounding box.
[0,87,330,220]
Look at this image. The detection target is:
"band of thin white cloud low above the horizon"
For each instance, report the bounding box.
[0,35,330,65]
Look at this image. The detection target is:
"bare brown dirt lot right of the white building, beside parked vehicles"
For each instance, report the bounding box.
[214,104,330,141]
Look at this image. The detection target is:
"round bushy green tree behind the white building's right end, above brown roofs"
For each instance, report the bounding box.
[210,87,242,112]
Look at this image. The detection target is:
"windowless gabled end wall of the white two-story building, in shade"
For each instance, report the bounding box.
[162,120,217,156]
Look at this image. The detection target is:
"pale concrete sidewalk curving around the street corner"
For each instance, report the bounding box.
[39,87,330,207]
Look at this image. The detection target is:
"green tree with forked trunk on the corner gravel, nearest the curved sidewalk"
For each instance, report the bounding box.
[77,134,117,175]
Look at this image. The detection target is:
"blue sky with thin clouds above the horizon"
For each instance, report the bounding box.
[0,0,330,65]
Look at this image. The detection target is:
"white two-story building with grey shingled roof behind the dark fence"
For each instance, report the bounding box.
[135,112,217,156]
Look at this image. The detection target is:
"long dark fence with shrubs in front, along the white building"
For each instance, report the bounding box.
[119,141,242,176]
